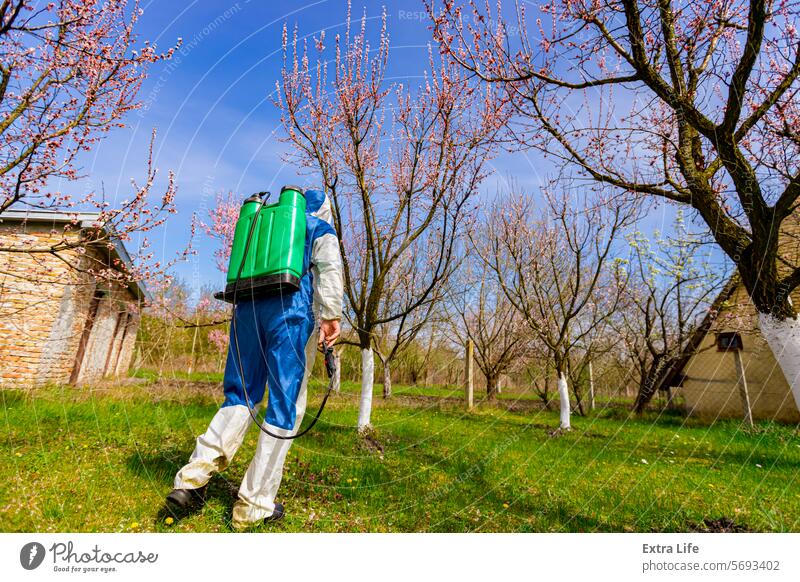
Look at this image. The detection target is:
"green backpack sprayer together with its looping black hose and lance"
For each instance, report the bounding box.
[214,186,336,440]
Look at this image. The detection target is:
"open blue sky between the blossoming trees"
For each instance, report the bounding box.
[64,0,688,298]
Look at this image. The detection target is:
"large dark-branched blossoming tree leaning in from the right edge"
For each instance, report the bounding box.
[428,0,800,404]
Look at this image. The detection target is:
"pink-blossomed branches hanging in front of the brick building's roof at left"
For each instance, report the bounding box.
[0,0,182,292]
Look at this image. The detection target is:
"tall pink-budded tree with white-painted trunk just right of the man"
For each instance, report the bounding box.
[278,4,504,429]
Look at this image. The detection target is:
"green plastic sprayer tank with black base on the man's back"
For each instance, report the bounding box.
[216,186,306,302]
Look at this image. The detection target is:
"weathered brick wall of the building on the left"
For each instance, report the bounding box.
[0,222,138,387]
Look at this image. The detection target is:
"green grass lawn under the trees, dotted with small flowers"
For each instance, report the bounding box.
[0,379,800,532]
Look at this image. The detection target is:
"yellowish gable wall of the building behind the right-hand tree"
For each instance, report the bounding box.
[679,286,800,422]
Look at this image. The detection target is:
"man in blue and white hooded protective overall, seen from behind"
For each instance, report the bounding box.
[167,190,342,529]
